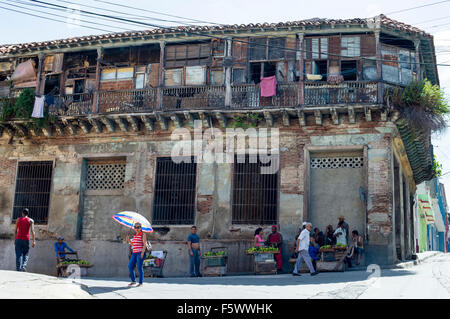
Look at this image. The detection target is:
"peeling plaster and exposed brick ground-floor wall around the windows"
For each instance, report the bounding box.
[0,118,412,264]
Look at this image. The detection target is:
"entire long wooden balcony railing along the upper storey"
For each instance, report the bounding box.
[0,81,402,116]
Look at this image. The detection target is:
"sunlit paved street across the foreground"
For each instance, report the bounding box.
[0,253,450,299]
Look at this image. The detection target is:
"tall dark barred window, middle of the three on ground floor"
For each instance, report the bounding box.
[152,157,197,225]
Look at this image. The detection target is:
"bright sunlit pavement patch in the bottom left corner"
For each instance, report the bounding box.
[0,270,93,299]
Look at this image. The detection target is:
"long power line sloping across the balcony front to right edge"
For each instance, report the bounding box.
[23,0,450,66]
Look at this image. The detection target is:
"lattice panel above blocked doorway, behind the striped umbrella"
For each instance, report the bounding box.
[86,159,126,190]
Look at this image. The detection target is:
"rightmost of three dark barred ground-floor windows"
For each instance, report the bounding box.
[232,155,278,225]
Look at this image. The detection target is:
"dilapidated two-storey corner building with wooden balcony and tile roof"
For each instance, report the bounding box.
[0,16,438,276]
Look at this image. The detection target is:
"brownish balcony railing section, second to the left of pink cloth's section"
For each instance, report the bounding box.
[98,88,158,113]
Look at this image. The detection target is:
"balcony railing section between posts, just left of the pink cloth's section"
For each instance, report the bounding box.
[162,85,225,110]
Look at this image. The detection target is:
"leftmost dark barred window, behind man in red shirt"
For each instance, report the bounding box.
[13,161,53,224]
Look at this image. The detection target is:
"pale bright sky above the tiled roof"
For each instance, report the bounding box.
[0,0,450,196]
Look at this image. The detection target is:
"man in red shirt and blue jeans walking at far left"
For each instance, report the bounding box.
[14,208,35,271]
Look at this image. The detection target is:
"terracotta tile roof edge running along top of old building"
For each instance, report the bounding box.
[0,15,432,55]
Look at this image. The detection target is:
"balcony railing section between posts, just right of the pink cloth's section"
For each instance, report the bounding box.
[305,81,377,106]
